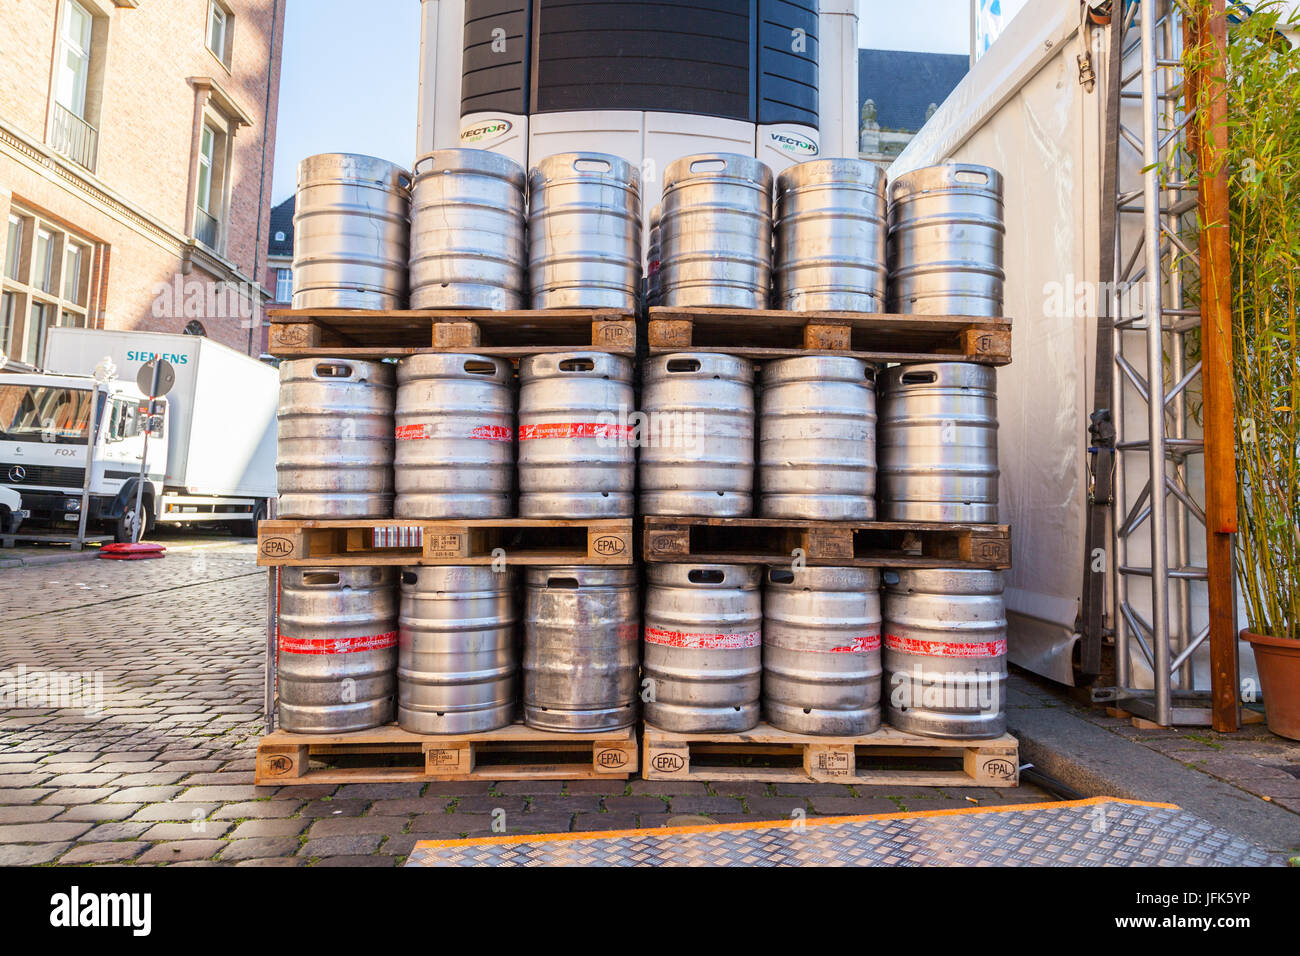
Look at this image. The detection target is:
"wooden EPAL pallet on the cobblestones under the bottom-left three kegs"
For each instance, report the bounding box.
[254,723,637,787]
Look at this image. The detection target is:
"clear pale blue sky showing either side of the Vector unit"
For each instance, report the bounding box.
[272,0,987,203]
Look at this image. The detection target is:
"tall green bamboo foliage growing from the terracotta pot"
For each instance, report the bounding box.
[1225,3,1300,640]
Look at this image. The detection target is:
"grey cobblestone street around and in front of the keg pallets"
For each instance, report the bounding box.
[0,544,1053,866]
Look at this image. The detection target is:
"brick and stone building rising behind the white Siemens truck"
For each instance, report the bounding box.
[0,0,286,364]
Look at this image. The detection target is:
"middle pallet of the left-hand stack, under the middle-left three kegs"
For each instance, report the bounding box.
[257,518,636,567]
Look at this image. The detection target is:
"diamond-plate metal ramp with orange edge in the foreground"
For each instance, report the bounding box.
[406,797,1275,866]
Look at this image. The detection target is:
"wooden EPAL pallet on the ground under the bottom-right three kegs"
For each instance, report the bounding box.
[641,723,1021,787]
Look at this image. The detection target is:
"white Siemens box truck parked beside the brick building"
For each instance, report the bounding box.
[0,328,280,541]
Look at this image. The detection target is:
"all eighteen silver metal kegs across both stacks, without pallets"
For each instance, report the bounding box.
[277,150,1006,737]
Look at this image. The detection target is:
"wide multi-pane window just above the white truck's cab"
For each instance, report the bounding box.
[0,204,94,365]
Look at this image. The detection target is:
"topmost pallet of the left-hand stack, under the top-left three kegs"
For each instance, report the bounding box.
[268,308,637,359]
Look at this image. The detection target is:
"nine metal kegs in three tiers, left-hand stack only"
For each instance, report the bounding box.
[277,150,641,734]
